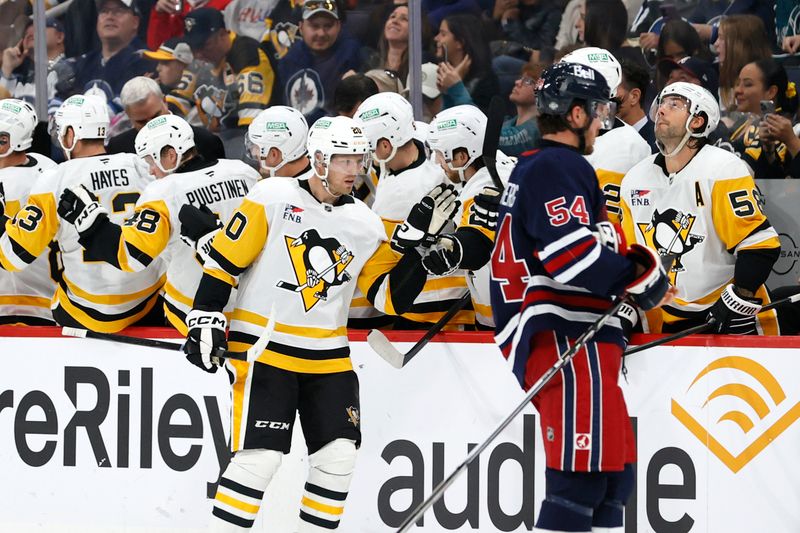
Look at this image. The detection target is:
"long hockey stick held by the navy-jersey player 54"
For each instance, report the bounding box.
[397,298,627,533]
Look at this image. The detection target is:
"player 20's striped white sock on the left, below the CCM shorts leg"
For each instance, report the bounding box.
[210,449,282,533]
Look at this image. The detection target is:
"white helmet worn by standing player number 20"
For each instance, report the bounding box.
[306,116,370,195]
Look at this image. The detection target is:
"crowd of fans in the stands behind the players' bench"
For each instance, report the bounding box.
[0,0,800,178]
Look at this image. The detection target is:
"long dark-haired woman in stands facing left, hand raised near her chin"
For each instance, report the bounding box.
[434,15,499,113]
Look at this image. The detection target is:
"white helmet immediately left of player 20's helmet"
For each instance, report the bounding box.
[245,105,308,176]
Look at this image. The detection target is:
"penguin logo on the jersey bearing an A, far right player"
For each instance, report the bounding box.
[636,209,705,284]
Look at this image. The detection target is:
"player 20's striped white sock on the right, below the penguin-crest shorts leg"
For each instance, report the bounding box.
[297,439,356,533]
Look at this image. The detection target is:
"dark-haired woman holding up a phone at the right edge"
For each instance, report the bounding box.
[725,58,800,179]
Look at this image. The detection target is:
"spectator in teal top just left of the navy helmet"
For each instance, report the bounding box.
[498,63,544,156]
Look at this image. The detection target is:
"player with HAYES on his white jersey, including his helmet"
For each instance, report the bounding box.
[0,95,164,333]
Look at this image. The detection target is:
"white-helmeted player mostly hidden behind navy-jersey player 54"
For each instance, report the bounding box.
[561,46,651,223]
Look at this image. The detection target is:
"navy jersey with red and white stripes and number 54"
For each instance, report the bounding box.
[490,140,635,382]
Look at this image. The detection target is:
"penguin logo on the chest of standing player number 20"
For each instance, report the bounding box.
[277,229,353,312]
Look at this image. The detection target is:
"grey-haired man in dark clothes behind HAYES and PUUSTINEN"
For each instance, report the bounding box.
[106,76,225,160]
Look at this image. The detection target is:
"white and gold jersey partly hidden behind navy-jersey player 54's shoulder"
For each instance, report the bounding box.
[586,119,652,224]
